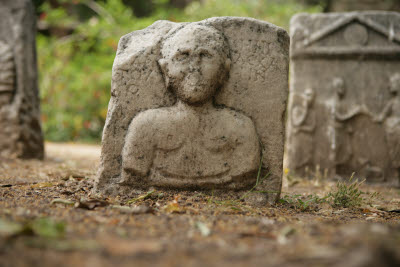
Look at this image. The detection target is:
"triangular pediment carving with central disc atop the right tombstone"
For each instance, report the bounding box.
[293,14,400,58]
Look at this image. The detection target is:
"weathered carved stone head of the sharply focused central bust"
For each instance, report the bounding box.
[159,24,231,105]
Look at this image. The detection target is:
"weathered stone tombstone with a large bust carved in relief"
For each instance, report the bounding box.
[96,17,289,203]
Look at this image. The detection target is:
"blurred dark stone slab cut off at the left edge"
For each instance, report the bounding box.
[0,0,44,159]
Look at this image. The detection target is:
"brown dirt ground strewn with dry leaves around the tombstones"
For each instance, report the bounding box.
[0,143,400,267]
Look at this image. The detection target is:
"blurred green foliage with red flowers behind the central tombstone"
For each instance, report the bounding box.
[37,0,322,142]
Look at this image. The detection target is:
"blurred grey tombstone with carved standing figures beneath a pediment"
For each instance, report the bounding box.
[285,11,400,184]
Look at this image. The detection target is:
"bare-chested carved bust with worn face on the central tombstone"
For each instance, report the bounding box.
[122,24,260,188]
